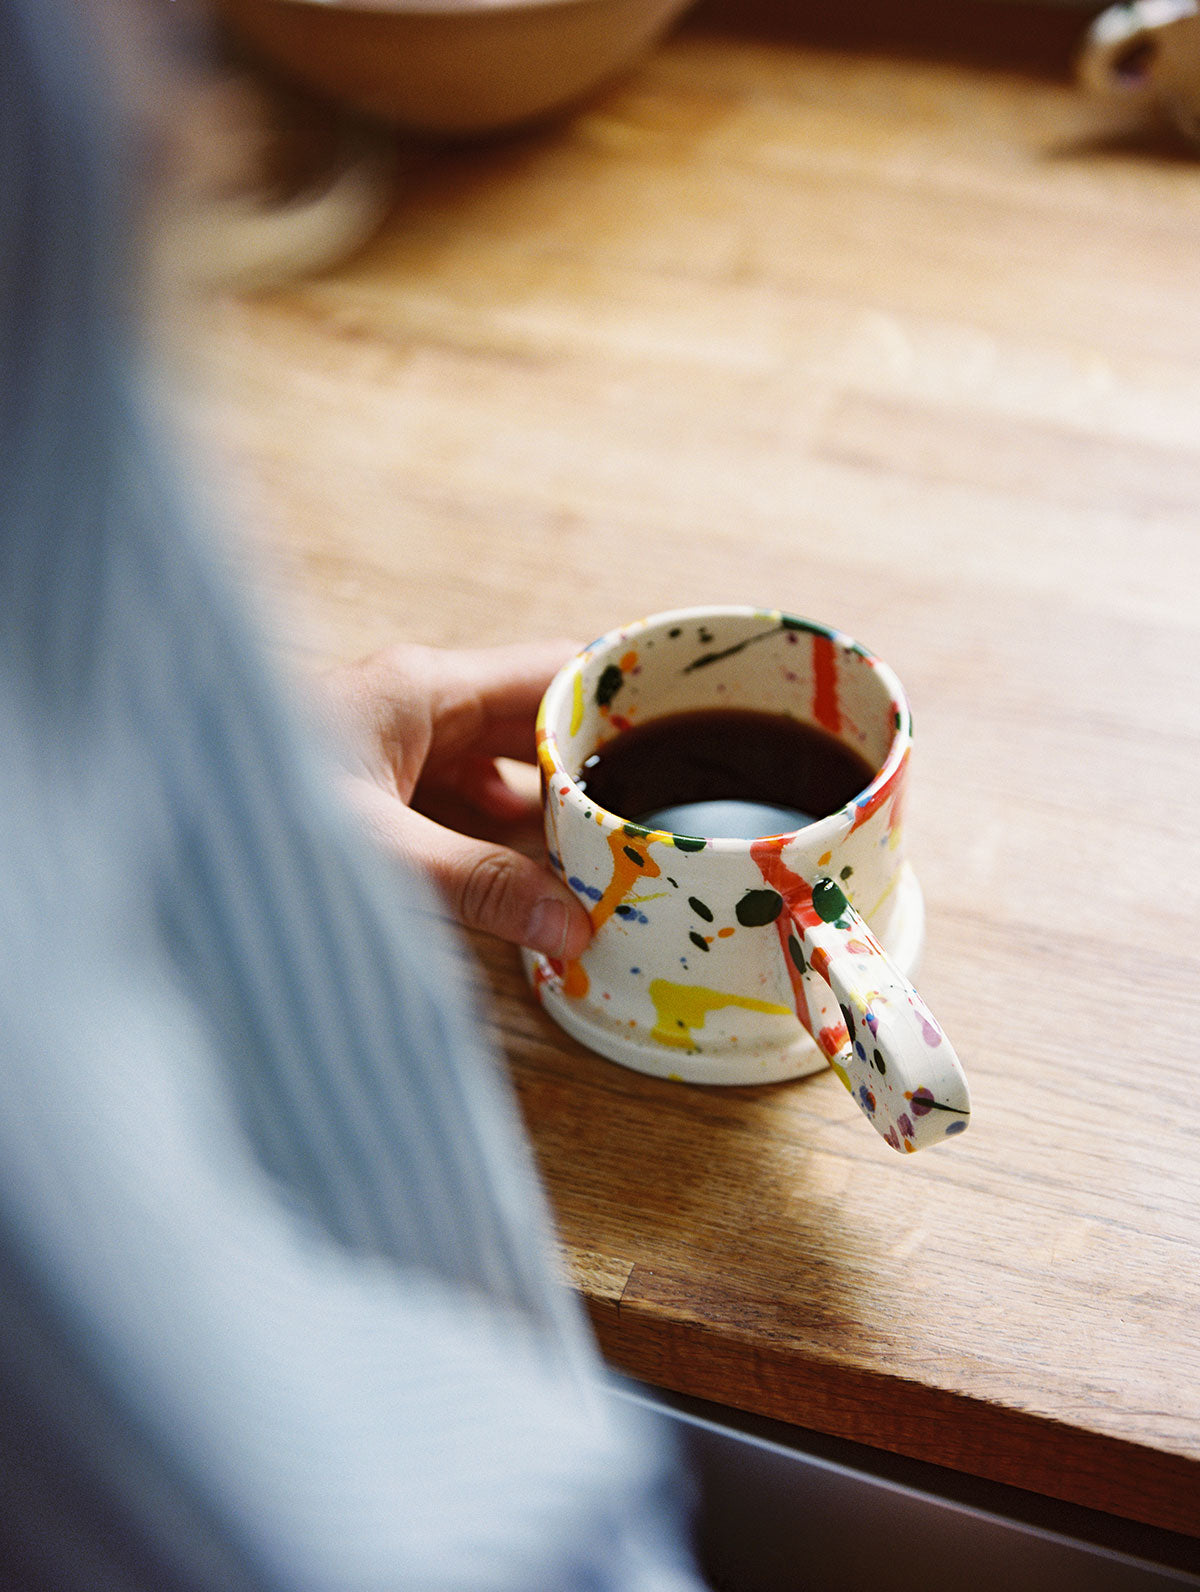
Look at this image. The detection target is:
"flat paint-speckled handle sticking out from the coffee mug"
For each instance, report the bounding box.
[789,879,971,1151]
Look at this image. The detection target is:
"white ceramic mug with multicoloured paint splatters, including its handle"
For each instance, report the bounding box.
[525,607,971,1149]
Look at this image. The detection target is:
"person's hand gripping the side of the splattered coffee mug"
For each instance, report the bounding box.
[323,642,592,957]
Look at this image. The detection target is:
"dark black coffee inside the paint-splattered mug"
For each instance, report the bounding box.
[576,708,875,841]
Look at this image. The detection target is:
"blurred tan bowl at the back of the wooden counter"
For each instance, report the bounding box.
[218,0,689,135]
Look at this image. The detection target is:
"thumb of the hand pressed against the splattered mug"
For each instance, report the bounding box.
[343,782,592,958]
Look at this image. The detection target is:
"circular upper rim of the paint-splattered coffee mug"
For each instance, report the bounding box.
[538,603,912,855]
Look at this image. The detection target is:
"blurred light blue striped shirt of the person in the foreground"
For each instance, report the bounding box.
[0,0,695,1592]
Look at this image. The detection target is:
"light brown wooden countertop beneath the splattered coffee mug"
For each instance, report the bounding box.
[198,6,1200,1536]
